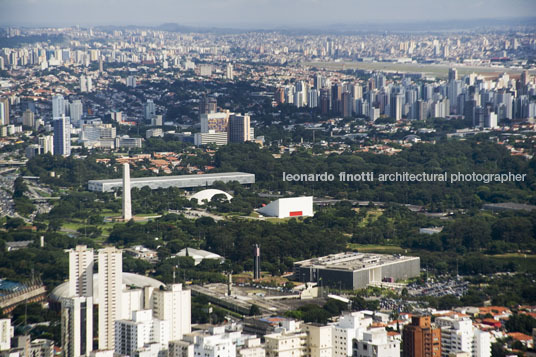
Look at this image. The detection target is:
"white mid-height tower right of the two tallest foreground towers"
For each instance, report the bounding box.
[153,284,192,341]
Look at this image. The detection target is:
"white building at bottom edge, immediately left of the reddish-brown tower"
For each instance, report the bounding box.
[352,327,400,357]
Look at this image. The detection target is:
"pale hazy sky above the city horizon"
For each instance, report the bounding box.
[0,0,536,28]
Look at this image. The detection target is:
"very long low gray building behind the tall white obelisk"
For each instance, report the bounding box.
[87,172,255,192]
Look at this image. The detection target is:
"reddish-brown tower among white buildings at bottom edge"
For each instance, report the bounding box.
[402,316,441,357]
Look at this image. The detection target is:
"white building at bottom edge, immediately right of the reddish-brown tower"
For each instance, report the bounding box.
[435,316,491,357]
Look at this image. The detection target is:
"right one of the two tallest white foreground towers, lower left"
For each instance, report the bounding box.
[97,247,123,350]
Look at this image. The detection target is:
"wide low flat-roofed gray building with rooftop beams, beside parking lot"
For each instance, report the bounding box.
[294,252,421,290]
